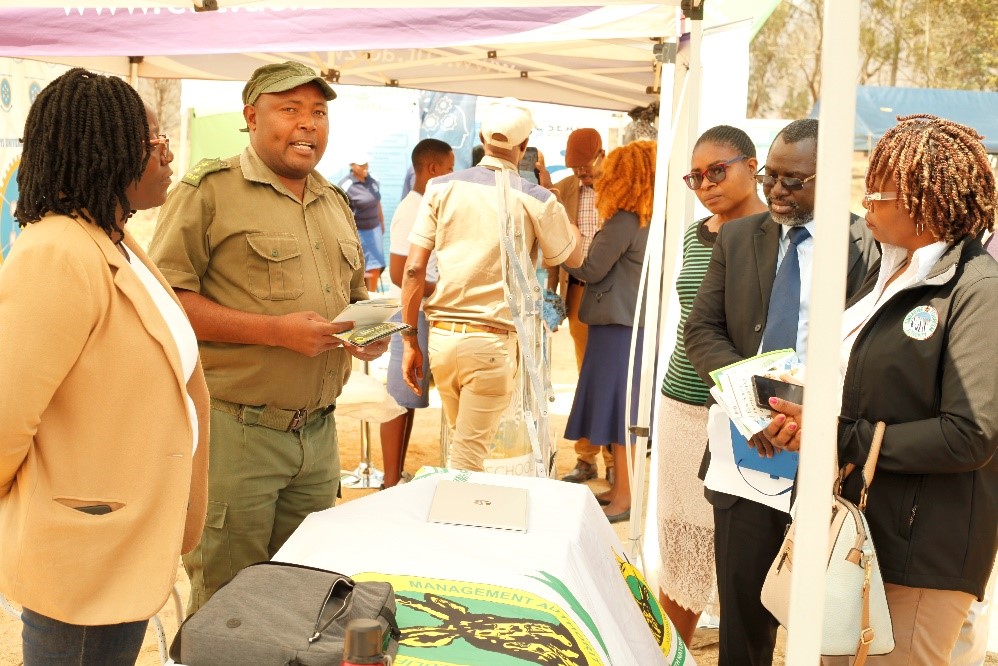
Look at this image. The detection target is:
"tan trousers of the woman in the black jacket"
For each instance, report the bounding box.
[821,583,974,666]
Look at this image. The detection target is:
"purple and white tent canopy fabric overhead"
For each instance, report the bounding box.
[0,0,771,110]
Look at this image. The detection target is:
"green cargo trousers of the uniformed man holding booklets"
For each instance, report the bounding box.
[183,400,340,615]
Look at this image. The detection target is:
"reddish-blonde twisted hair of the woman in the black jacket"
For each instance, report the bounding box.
[866,114,998,243]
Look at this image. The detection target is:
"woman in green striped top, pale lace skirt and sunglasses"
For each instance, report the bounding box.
[657,125,766,645]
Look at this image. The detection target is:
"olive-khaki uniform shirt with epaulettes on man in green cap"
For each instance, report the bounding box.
[149,147,368,409]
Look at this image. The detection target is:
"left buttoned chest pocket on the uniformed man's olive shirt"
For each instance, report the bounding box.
[246,234,305,301]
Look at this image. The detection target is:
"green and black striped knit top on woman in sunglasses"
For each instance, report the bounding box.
[662,217,717,405]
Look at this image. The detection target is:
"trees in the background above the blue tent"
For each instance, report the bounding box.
[747,0,998,118]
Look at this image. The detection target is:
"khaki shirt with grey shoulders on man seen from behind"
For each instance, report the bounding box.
[409,156,575,330]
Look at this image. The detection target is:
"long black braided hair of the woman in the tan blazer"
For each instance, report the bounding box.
[14,68,152,240]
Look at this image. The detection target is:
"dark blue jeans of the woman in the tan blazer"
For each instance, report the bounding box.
[21,608,149,666]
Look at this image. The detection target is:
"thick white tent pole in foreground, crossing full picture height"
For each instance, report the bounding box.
[787,0,859,664]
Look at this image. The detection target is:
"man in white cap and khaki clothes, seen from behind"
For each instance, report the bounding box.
[402,98,582,471]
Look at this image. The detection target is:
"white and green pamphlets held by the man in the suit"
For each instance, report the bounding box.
[710,349,804,439]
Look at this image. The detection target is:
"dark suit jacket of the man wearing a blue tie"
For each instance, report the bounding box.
[684,212,880,508]
